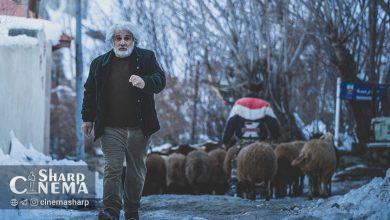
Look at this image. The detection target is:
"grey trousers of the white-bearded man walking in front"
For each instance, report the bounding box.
[101,127,150,214]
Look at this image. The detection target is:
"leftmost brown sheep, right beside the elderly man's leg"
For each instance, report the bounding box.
[142,153,166,195]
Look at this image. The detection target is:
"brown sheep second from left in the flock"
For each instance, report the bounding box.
[167,153,187,194]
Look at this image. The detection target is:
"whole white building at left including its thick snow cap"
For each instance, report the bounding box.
[0,14,62,154]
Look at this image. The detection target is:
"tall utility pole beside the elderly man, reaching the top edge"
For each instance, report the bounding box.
[75,0,85,160]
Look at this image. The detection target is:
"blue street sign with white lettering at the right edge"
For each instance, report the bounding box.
[340,82,389,101]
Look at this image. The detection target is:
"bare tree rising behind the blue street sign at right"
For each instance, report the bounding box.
[301,0,389,143]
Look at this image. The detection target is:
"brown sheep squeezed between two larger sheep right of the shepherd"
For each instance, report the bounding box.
[272,142,304,197]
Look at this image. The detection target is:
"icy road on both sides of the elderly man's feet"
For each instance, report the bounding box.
[0,195,308,220]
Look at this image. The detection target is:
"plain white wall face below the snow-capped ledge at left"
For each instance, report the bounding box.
[0,32,51,154]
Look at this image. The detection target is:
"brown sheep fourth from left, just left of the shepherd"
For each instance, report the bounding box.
[208,149,228,195]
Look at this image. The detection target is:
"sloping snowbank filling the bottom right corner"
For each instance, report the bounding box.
[292,169,390,219]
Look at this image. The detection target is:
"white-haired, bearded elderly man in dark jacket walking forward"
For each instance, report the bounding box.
[81,22,165,219]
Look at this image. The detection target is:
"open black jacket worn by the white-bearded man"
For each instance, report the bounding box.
[81,47,165,141]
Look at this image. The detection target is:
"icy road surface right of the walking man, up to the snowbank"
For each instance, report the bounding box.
[141,195,308,220]
